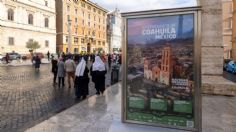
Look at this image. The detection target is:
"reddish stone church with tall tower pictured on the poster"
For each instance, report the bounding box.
[144,44,193,91]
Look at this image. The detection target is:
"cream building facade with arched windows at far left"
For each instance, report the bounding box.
[0,0,56,54]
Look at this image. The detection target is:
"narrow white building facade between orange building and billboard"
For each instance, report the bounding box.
[107,9,122,53]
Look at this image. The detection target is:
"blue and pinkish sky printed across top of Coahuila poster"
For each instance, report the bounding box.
[128,15,193,44]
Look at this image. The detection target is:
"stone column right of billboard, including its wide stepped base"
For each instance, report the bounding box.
[199,0,236,95]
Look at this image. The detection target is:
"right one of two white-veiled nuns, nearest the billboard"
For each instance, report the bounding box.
[90,56,107,95]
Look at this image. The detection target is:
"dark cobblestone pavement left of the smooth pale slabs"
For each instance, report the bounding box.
[0,64,110,132]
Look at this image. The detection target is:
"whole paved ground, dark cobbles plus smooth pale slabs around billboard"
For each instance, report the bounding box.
[0,64,236,132]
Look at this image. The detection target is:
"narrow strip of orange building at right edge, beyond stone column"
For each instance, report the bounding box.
[222,0,233,59]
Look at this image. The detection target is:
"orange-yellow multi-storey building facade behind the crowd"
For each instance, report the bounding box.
[56,0,108,53]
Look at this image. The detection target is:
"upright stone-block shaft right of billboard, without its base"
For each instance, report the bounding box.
[199,0,224,76]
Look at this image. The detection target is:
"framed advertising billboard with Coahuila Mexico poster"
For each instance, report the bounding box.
[123,7,201,131]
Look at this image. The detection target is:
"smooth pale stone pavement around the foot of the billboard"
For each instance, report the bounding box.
[26,84,236,132]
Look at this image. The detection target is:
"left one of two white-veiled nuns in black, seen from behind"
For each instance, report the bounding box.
[74,58,89,99]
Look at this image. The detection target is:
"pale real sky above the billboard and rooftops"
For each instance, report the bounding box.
[90,0,197,12]
